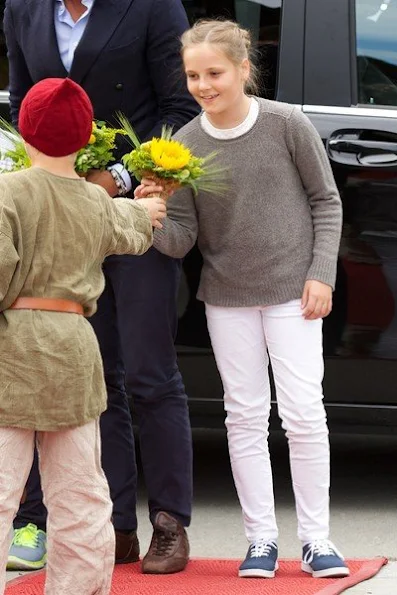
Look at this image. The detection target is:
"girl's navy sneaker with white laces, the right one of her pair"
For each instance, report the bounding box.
[301,539,350,578]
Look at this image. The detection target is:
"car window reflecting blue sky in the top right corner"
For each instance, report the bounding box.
[356,0,397,106]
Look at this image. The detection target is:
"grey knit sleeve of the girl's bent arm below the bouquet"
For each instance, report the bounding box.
[153,188,200,258]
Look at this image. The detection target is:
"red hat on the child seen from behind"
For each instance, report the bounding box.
[18,78,94,157]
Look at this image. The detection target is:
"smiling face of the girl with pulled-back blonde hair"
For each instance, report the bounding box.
[183,43,249,126]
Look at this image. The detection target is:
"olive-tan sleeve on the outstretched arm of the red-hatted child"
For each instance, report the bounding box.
[105,198,153,256]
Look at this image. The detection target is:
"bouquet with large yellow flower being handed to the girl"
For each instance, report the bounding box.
[118,113,227,199]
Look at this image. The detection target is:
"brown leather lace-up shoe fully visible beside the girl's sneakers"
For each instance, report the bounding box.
[142,512,190,574]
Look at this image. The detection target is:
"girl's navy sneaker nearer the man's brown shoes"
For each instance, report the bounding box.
[238,539,278,578]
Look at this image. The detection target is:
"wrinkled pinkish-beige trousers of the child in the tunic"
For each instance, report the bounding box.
[0,420,115,595]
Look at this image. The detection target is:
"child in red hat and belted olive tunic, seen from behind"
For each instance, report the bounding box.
[0,79,166,595]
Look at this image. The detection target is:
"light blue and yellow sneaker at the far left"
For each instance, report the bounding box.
[7,523,47,570]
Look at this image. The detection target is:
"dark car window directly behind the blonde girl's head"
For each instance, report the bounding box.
[183,0,282,99]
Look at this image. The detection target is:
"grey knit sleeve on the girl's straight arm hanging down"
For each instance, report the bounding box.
[287,108,342,288]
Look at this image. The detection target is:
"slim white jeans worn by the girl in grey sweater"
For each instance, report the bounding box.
[206,300,330,542]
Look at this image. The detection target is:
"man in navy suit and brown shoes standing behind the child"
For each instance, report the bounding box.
[4,0,198,573]
